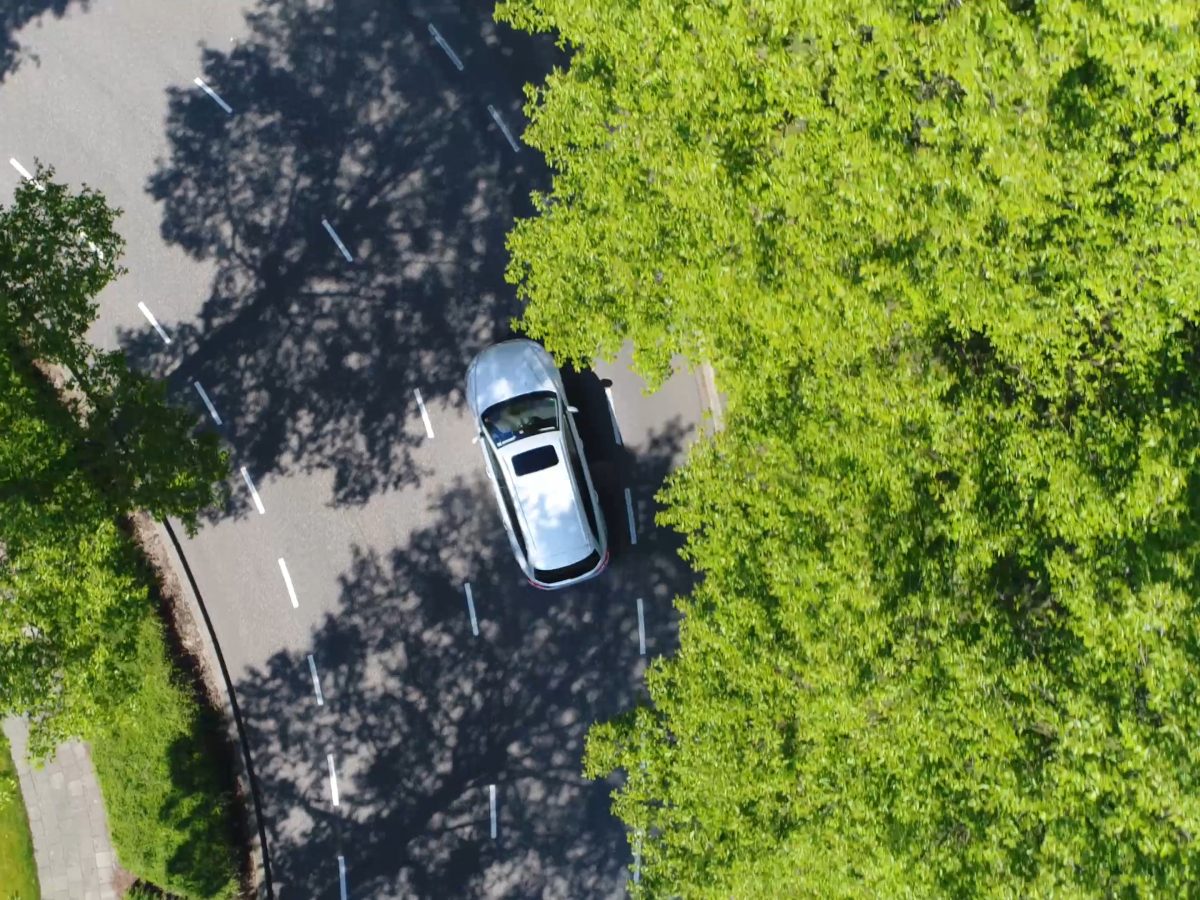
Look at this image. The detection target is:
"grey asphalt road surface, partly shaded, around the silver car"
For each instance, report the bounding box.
[0,0,701,898]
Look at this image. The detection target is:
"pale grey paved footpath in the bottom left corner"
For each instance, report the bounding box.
[4,719,116,900]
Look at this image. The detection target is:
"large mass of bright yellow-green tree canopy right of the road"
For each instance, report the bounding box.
[498,0,1200,898]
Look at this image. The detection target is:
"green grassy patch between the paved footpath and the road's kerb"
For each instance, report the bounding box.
[91,610,239,900]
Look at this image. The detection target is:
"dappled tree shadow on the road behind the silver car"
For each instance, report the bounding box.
[236,424,690,900]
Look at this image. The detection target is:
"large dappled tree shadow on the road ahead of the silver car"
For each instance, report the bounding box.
[120,0,556,516]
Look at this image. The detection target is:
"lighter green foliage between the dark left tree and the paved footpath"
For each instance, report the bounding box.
[0,355,150,756]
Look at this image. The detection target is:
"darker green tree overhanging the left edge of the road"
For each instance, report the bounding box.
[0,166,228,530]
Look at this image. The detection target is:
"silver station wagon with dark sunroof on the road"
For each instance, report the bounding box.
[467,340,608,590]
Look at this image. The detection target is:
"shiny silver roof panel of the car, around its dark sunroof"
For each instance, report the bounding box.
[497,431,595,570]
